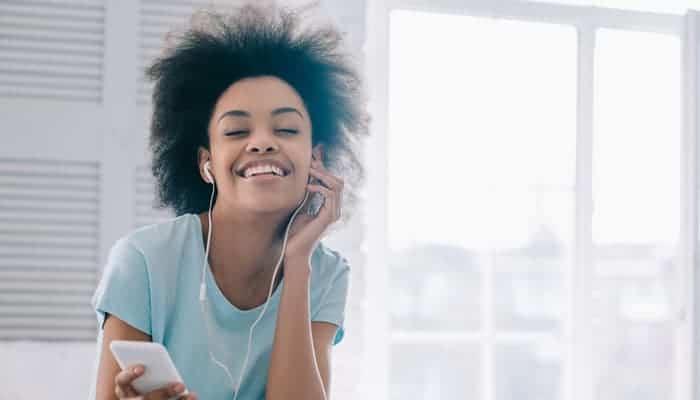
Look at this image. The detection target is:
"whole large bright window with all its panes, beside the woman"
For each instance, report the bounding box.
[368,1,691,400]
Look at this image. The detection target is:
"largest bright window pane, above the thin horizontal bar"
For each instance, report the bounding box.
[388,11,577,340]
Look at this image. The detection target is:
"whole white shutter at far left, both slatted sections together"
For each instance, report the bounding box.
[0,0,109,340]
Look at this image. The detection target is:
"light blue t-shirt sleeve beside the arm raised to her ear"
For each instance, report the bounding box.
[311,256,350,345]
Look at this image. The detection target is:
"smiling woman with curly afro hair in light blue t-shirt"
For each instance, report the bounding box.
[91,6,368,400]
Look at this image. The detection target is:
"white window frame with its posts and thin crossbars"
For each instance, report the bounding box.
[362,0,700,400]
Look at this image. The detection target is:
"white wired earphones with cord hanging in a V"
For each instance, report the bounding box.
[199,160,309,400]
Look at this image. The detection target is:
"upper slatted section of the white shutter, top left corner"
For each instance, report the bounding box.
[0,0,105,103]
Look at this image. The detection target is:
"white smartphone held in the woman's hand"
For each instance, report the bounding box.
[109,340,189,400]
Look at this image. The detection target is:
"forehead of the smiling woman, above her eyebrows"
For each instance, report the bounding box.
[215,76,306,117]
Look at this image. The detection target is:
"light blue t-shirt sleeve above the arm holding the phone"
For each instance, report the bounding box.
[92,238,151,335]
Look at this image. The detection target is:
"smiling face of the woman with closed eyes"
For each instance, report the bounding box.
[199,76,322,213]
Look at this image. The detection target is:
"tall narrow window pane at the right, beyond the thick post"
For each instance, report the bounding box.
[591,29,681,400]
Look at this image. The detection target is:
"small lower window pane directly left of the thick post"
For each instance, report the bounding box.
[494,340,563,400]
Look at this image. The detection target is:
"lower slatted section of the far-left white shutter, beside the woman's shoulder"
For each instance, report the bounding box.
[0,159,99,340]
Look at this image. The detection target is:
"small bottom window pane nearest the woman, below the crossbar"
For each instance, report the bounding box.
[389,343,481,400]
